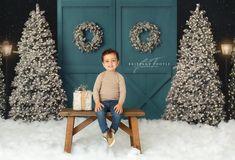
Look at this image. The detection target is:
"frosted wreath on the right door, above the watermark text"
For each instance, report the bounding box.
[129,21,160,53]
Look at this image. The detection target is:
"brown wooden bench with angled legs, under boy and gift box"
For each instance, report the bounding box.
[59,108,145,153]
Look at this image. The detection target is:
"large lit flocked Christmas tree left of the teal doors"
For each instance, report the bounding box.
[9,4,66,121]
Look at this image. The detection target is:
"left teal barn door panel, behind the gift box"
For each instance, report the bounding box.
[57,0,115,106]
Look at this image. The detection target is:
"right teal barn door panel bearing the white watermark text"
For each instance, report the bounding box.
[116,0,177,118]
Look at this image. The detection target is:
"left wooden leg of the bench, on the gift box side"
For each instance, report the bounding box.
[64,117,75,153]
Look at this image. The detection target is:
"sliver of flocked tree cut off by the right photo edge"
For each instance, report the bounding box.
[228,50,235,119]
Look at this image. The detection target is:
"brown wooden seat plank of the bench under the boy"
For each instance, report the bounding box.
[59,108,145,117]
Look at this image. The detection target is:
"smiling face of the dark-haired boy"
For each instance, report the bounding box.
[102,53,119,71]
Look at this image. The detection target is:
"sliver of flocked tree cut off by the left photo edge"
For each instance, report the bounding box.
[0,54,6,118]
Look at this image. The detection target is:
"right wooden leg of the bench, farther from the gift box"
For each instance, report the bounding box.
[129,117,141,152]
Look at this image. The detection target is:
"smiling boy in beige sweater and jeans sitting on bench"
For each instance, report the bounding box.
[93,49,126,147]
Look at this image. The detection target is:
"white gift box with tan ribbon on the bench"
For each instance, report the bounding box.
[73,90,92,110]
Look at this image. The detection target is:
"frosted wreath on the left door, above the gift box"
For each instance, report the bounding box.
[74,22,103,52]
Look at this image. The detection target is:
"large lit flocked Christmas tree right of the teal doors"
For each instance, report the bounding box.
[163,4,224,125]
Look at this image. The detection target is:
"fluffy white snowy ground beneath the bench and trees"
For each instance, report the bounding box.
[0,119,235,160]
